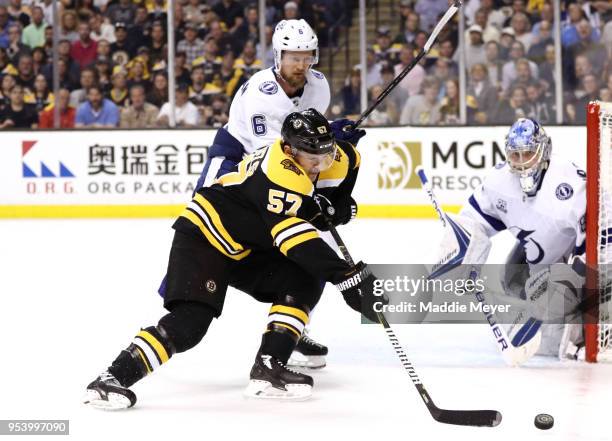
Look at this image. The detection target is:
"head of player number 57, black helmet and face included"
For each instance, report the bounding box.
[281,109,336,172]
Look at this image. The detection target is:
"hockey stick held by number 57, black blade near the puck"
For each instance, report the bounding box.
[325,217,502,427]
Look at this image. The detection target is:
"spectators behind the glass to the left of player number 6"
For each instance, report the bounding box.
[0,0,345,128]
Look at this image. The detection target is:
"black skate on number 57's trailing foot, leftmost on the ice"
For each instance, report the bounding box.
[83,371,136,410]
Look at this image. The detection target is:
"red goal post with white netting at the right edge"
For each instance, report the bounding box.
[585,102,612,362]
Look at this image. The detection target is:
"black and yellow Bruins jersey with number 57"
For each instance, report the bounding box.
[173,140,360,282]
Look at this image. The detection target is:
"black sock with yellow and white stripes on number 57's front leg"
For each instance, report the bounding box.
[260,305,309,363]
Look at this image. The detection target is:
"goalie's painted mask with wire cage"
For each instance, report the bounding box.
[506,118,552,196]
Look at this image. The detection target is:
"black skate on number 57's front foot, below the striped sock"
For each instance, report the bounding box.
[244,354,313,401]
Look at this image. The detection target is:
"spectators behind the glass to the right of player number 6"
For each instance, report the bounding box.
[334,0,612,125]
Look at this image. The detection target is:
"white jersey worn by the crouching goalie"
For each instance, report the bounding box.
[461,156,586,265]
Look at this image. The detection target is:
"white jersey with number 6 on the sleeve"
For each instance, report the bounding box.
[226,68,330,153]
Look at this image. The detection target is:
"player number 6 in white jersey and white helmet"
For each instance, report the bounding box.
[159,19,365,368]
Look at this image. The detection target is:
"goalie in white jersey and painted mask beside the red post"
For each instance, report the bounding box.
[436,118,586,364]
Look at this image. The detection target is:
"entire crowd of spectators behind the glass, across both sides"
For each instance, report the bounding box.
[0,0,612,128]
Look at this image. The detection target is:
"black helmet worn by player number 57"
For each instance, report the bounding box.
[281,108,336,155]
